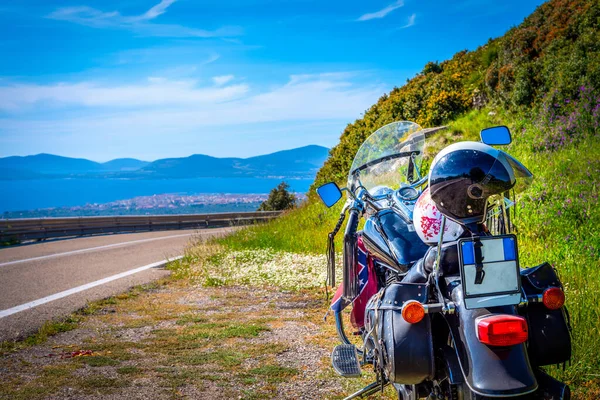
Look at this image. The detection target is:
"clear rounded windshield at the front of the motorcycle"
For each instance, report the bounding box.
[348,121,425,195]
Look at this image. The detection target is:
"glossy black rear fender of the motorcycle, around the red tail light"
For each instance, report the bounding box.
[444,279,538,397]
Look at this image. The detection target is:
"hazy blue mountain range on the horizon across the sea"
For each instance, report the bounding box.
[0,145,329,180]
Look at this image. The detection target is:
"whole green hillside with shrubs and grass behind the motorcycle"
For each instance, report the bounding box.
[209,0,600,399]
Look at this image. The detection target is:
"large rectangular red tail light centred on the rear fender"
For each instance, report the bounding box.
[477,315,528,346]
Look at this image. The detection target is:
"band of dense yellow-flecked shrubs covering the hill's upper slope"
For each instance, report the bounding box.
[311,0,600,189]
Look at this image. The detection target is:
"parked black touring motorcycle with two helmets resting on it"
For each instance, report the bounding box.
[317,121,571,400]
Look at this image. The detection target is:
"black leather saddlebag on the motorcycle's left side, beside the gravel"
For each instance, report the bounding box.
[366,283,435,385]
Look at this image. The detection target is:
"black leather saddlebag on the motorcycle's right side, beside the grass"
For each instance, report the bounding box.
[521,263,571,366]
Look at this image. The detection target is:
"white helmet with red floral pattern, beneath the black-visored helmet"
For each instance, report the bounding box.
[413,188,464,244]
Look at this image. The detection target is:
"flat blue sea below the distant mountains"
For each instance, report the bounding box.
[0,178,313,213]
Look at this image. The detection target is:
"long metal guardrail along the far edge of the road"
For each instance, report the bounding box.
[0,211,281,243]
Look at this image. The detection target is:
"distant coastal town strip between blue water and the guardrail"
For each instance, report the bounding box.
[0,193,306,219]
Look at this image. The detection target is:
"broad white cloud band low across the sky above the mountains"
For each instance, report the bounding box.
[0,74,384,137]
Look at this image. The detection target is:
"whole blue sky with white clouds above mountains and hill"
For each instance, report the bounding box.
[0,0,542,161]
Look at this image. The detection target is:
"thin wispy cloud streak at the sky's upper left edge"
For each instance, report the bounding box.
[46,0,242,38]
